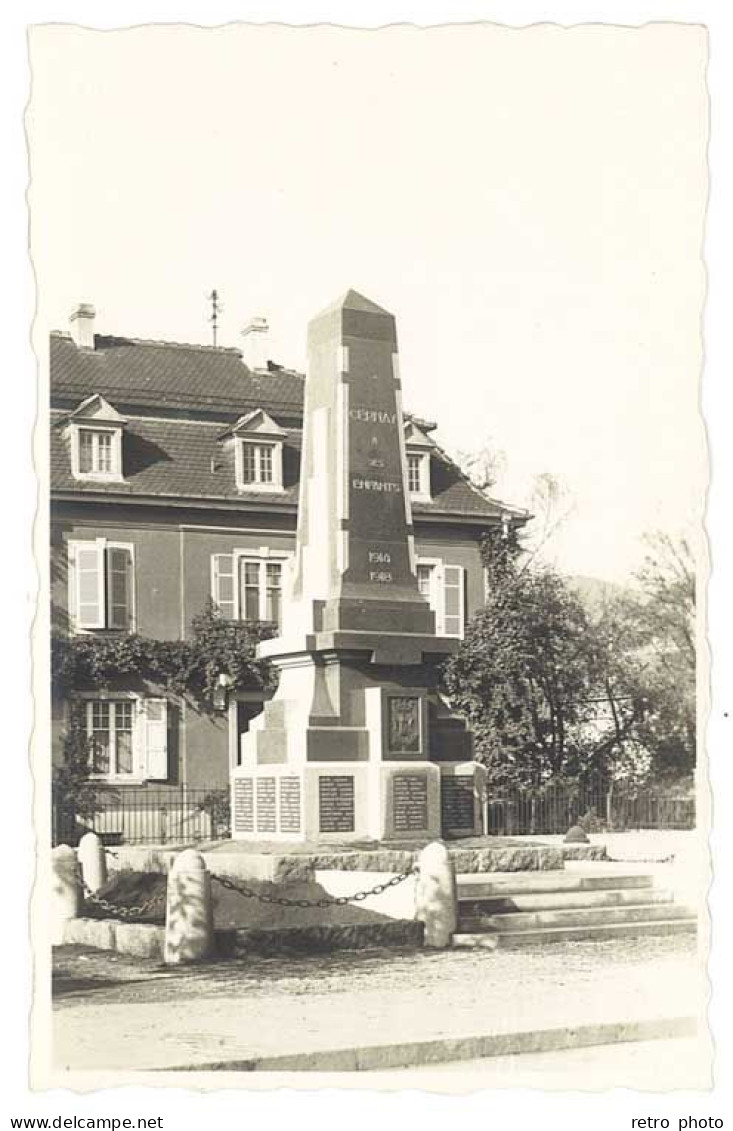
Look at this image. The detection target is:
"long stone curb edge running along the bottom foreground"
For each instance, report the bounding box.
[157,1017,698,1072]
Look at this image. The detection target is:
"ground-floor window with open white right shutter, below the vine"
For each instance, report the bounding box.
[84,696,169,782]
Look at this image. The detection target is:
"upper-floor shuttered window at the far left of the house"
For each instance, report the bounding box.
[69,538,135,632]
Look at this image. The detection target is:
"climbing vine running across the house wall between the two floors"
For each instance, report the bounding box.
[51,604,274,713]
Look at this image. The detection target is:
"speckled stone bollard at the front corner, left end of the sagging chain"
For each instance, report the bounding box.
[163,848,214,966]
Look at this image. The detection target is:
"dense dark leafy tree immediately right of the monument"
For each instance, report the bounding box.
[443,529,593,785]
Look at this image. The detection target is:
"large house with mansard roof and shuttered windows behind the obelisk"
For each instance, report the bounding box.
[50,305,523,832]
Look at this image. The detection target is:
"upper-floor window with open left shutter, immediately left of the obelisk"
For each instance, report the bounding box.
[212,551,285,624]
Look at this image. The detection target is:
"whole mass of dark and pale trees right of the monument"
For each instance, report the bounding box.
[443,529,695,789]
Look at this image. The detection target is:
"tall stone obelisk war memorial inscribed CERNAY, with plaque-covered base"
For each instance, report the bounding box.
[232,291,483,841]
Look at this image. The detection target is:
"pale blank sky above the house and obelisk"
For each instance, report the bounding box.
[27,24,708,580]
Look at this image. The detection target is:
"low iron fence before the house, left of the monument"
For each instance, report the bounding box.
[52,786,230,845]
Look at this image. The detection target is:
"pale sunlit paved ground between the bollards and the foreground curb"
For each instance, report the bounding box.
[54,936,704,1072]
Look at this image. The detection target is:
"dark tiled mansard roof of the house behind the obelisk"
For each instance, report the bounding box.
[51,325,526,524]
